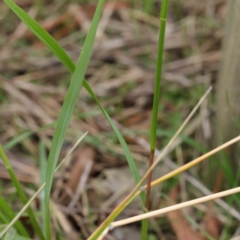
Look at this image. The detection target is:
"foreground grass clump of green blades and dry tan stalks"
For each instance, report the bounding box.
[0,0,240,240]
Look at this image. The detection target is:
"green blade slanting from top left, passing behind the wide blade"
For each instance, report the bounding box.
[4,0,145,204]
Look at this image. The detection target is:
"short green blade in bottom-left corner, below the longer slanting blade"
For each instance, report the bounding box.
[0,196,29,237]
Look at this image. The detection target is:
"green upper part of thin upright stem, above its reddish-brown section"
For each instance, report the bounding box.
[150,0,168,151]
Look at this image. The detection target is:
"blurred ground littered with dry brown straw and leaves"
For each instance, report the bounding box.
[0,0,240,239]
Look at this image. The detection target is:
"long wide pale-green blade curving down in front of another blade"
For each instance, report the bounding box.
[45,0,104,240]
